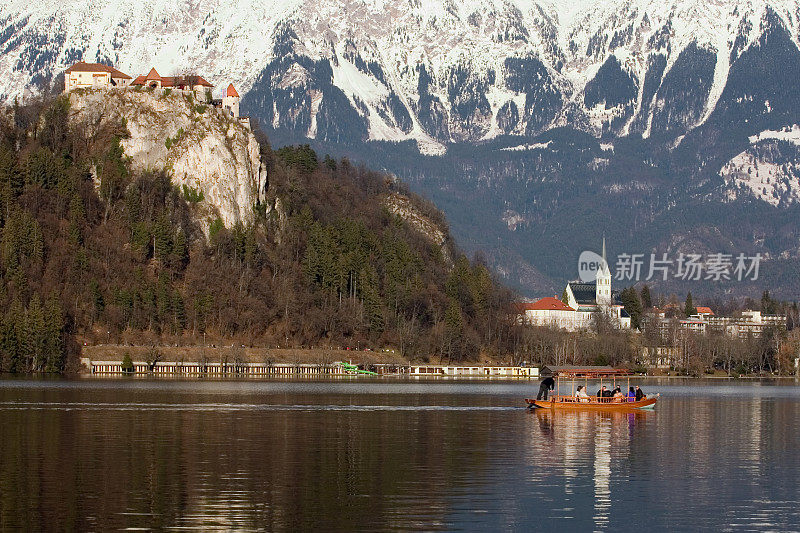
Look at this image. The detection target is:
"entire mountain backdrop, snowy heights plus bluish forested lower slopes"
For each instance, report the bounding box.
[0,0,800,297]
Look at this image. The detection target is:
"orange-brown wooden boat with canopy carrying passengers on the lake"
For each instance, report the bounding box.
[525,366,659,411]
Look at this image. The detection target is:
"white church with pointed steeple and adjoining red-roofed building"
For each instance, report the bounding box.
[520,239,631,331]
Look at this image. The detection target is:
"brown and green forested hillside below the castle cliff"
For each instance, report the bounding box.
[0,98,509,372]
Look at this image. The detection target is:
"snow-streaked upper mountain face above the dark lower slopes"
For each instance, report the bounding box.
[0,0,800,153]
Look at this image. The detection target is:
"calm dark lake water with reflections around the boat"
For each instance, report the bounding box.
[0,379,800,531]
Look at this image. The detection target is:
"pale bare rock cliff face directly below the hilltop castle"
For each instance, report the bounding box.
[70,89,267,227]
